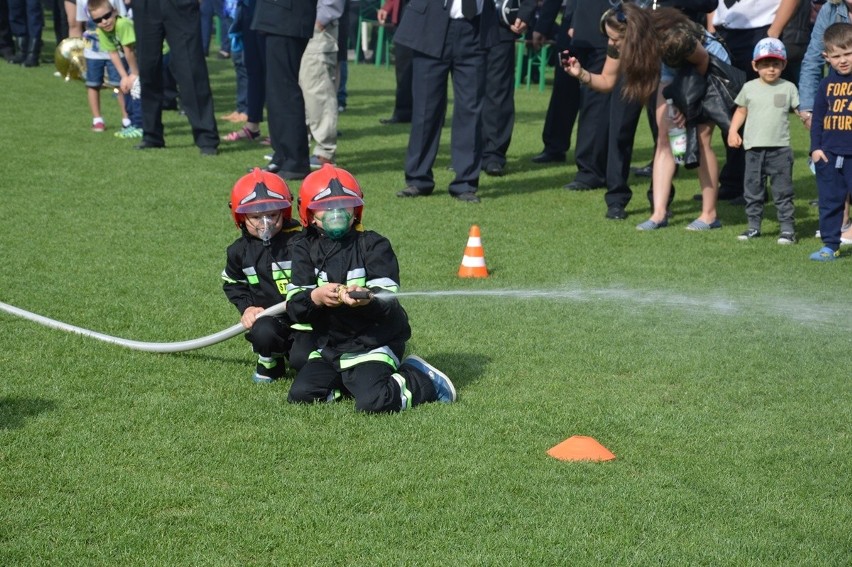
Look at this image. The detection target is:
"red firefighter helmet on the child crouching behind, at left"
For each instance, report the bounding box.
[228,167,293,227]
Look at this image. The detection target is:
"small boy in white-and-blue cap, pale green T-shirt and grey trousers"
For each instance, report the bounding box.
[728,37,799,244]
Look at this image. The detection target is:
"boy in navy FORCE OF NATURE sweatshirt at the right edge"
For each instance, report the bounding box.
[810,23,852,262]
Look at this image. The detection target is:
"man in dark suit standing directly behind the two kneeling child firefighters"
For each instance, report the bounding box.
[251,0,317,179]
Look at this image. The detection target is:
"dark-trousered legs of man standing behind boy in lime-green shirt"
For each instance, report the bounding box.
[133,0,219,155]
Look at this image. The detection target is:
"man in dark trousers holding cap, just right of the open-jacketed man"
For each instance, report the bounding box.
[482,0,536,176]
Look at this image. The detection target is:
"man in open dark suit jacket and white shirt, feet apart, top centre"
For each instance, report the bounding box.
[394,0,510,203]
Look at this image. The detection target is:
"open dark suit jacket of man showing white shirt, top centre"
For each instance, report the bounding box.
[393,0,499,57]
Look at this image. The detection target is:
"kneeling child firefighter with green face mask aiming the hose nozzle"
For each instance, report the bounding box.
[287,164,456,413]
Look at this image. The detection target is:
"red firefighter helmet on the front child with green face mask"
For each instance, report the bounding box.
[299,163,364,227]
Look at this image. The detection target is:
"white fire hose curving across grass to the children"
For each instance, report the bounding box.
[0,301,286,353]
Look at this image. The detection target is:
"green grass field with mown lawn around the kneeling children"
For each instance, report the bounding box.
[0,42,852,566]
